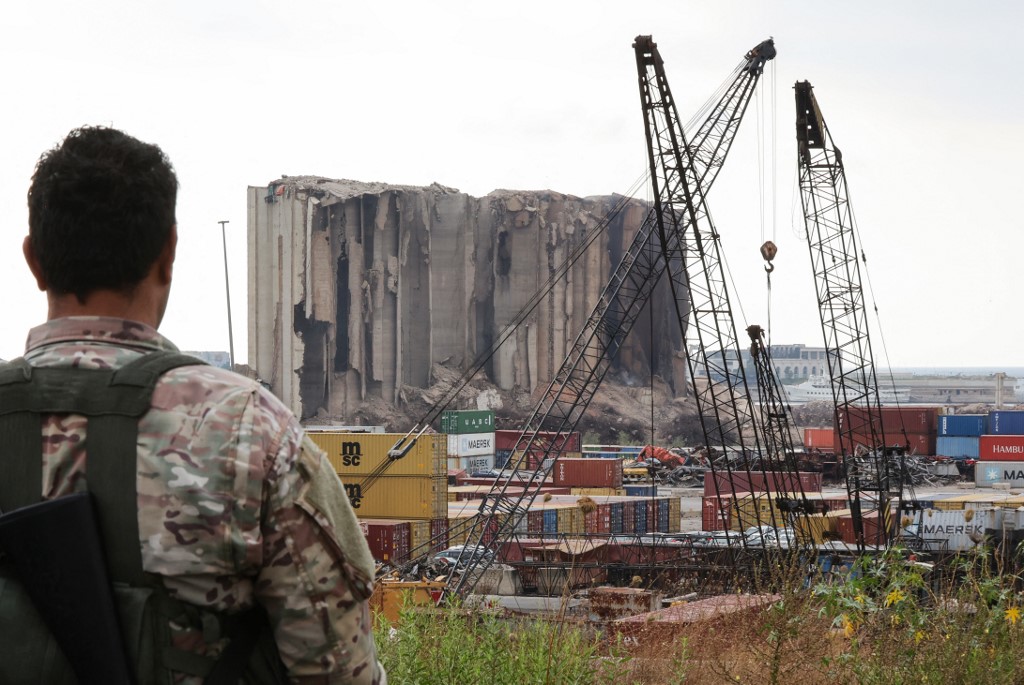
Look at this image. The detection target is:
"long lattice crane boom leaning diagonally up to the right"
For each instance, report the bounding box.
[451,37,775,592]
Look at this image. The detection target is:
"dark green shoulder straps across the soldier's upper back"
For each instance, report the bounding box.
[0,351,204,585]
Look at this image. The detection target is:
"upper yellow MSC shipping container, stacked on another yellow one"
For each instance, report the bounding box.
[306,427,447,480]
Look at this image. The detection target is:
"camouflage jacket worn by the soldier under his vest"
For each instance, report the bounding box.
[25,316,387,685]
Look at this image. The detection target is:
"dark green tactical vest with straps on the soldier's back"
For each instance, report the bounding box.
[0,352,288,685]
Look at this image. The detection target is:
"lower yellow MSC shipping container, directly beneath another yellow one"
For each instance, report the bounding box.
[343,476,447,519]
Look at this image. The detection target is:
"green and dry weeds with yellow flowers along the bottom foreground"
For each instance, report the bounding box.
[377,551,1024,685]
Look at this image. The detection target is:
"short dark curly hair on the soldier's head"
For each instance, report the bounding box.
[29,127,178,303]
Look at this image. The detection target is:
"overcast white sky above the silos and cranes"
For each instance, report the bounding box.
[0,0,1024,367]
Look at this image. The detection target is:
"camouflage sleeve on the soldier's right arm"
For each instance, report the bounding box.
[255,419,387,685]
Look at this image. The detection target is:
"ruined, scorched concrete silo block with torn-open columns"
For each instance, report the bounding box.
[248,177,685,418]
